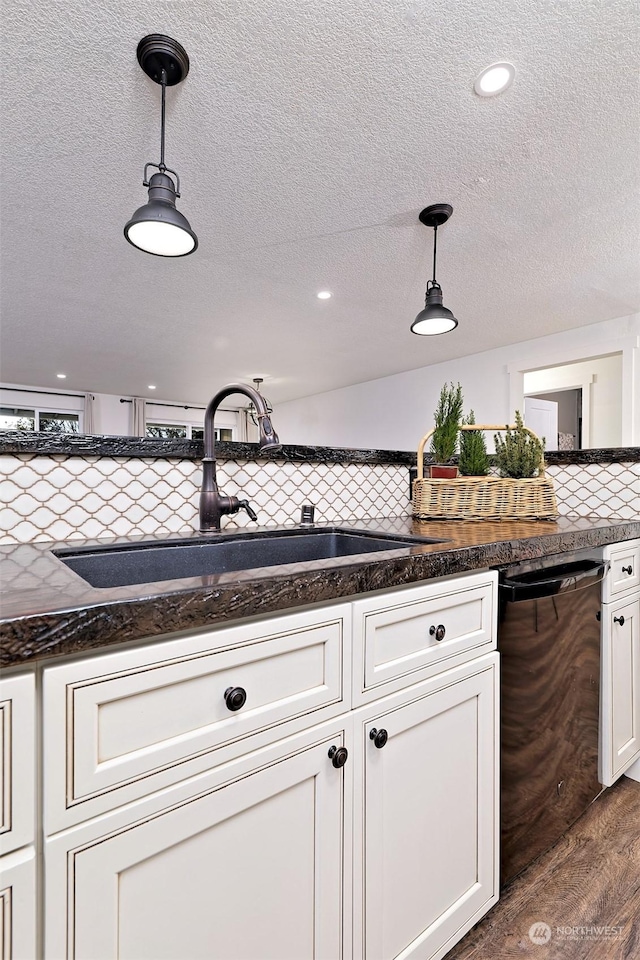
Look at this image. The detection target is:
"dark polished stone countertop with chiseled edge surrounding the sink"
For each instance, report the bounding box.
[0,517,640,667]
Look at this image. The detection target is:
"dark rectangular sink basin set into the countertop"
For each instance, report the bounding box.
[53,527,444,587]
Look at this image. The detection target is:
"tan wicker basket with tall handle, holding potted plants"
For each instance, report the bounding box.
[413,423,558,520]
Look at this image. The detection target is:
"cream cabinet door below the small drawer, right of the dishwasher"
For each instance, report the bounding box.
[600,599,640,787]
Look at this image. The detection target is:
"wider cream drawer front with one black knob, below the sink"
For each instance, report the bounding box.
[44,605,348,829]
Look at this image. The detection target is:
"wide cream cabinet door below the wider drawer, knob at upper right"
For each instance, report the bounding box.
[46,737,345,960]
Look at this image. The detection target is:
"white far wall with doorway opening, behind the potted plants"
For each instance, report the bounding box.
[273,314,640,450]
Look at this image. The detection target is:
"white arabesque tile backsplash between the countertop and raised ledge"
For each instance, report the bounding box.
[0,454,640,543]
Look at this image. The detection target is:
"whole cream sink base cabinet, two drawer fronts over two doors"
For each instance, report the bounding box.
[43,571,498,960]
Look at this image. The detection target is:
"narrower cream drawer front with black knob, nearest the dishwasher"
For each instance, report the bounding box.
[353,572,497,704]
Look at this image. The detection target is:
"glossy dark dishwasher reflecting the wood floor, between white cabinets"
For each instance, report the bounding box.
[498,551,607,884]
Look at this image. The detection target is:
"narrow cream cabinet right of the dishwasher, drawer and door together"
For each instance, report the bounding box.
[600,540,640,787]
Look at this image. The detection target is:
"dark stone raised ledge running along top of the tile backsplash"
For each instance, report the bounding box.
[0,430,640,466]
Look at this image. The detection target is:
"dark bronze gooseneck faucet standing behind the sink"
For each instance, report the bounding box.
[200,383,282,533]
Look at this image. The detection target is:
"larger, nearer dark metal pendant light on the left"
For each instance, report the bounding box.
[124,33,198,257]
